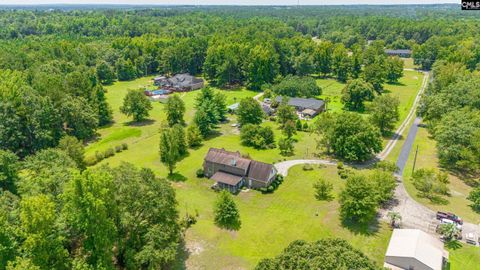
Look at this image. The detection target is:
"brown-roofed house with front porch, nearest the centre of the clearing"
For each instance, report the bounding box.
[203,148,277,192]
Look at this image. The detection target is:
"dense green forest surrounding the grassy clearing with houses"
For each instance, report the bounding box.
[0,5,480,269]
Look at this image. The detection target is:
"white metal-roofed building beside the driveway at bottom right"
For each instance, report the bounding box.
[383,229,448,270]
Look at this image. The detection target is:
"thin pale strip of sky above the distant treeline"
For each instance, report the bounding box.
[0,0,460,5]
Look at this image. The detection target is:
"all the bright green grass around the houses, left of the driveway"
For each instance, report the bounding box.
[87,72,422,269]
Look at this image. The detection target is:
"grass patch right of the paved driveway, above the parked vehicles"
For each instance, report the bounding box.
[403,122,480,224]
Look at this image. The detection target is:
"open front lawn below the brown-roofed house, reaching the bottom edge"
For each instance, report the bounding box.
[174,166,391,269]
